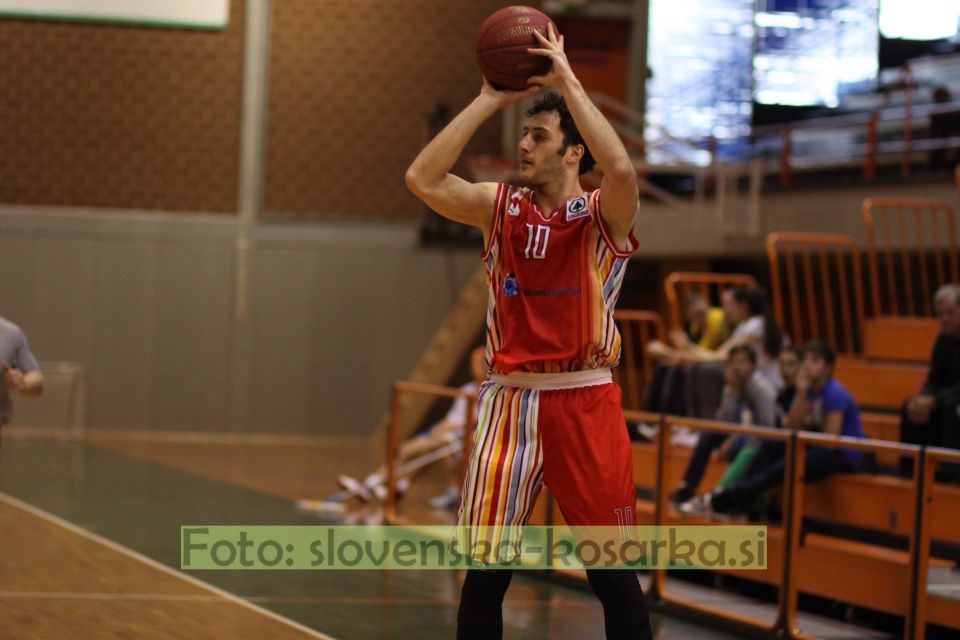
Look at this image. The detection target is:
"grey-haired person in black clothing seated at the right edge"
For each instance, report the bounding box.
[900,284,960,482]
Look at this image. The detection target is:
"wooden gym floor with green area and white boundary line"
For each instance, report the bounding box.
[0,432,876,640]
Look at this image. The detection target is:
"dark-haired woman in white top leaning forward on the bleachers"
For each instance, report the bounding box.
[665,287,783,419]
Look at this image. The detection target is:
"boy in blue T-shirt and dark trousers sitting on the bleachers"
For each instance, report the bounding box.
[709,340,864,513]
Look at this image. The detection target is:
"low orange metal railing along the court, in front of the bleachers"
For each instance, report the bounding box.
[385,382,960,640]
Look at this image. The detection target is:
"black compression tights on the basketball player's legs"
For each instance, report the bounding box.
[457,570,653,640]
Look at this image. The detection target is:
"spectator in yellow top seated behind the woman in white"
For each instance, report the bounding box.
[646,292,727,415]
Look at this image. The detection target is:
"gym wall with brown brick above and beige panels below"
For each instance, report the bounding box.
[0,0,502,434]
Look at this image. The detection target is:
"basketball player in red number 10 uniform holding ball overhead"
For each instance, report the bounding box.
[406,29,652,638]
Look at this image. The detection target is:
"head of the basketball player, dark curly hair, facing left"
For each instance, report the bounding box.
[517,92,596,186]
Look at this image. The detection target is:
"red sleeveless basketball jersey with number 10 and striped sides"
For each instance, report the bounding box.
[483,184,637,375]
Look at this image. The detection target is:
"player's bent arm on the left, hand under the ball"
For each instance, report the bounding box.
[406,81,538,236]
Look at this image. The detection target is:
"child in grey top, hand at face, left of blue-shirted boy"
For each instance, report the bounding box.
[670,344,777,505]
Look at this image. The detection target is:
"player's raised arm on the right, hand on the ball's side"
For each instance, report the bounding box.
[530,27,640,248]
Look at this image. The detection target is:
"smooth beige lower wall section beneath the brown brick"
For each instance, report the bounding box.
[0,207,479,435]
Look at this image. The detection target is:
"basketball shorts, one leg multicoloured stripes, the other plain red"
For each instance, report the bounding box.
[460,370,636,526]
